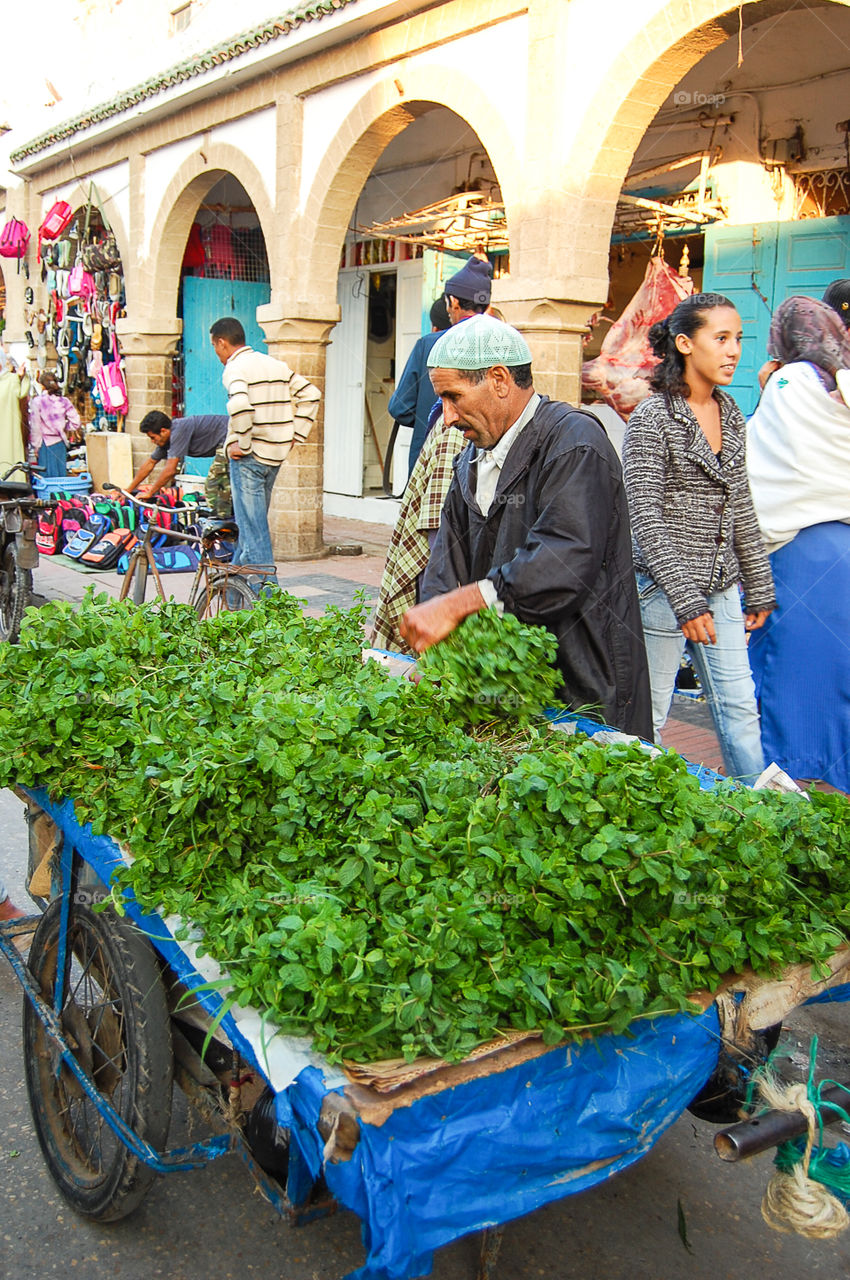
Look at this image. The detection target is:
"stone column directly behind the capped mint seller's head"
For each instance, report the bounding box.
[498,294,599,404]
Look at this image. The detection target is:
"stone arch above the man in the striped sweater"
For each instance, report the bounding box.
[138,141,275,324]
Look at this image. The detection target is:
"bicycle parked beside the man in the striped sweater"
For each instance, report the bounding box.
[104,484,277,618]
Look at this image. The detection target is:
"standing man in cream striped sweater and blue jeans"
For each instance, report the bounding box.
[210,316,321,590]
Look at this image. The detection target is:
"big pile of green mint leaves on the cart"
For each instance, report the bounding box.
[0,591,850,1062]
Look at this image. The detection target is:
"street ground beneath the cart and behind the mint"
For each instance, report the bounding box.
[0,526,850,1280]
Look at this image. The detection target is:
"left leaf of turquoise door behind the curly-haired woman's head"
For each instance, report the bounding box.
[703,223,778,415]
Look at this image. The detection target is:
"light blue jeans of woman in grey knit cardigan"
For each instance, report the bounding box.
[638,573,764,783]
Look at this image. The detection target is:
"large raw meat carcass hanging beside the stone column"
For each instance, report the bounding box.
[581,255,694,420]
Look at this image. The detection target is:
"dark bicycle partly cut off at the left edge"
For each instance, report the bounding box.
[0,462,56,644]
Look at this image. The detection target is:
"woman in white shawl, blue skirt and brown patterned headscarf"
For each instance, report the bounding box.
[746,297,850,791]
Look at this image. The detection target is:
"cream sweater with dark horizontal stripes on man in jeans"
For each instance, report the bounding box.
[221,347,321,466]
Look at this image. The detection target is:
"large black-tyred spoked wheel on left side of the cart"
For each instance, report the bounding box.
[23,901,174,1222]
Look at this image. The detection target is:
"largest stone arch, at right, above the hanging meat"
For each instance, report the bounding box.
[557,0,850,305]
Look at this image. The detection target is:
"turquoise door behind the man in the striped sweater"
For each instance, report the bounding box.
[183,275,271,417]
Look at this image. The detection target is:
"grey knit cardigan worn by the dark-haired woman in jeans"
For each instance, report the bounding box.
[623,389,776,626]
